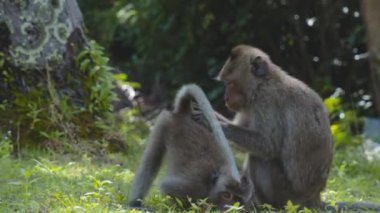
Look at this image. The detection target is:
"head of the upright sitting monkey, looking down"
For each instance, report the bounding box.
[216,45,272,112]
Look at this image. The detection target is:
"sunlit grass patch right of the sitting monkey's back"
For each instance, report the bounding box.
[323,147,380,203]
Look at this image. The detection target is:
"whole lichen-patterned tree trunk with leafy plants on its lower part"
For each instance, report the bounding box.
[0,0,131,153]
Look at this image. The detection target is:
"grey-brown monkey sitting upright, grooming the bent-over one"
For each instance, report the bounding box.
[212,45,333,208]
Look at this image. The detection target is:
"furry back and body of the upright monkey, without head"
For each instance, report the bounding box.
[250,72,332,206]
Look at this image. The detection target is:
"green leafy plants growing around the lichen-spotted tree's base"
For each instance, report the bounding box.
[0,41,141,153]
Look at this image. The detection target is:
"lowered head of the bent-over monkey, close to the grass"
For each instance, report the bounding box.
[208,171,254,211]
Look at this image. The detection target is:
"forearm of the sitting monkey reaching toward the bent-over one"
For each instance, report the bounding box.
[221,123,278,159]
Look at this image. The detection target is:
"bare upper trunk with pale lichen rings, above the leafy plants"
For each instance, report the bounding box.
[0,0,86,100]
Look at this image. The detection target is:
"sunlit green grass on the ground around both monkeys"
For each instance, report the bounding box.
[0,148,380,212]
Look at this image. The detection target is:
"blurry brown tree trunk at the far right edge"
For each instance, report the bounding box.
[361,0,380,115]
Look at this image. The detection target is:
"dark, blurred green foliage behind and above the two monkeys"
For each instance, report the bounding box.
[79,0,371,114]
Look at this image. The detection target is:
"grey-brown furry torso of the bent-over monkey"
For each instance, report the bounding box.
[165,113,225,179]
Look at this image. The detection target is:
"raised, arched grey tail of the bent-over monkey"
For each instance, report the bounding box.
[174,84,240,180]
